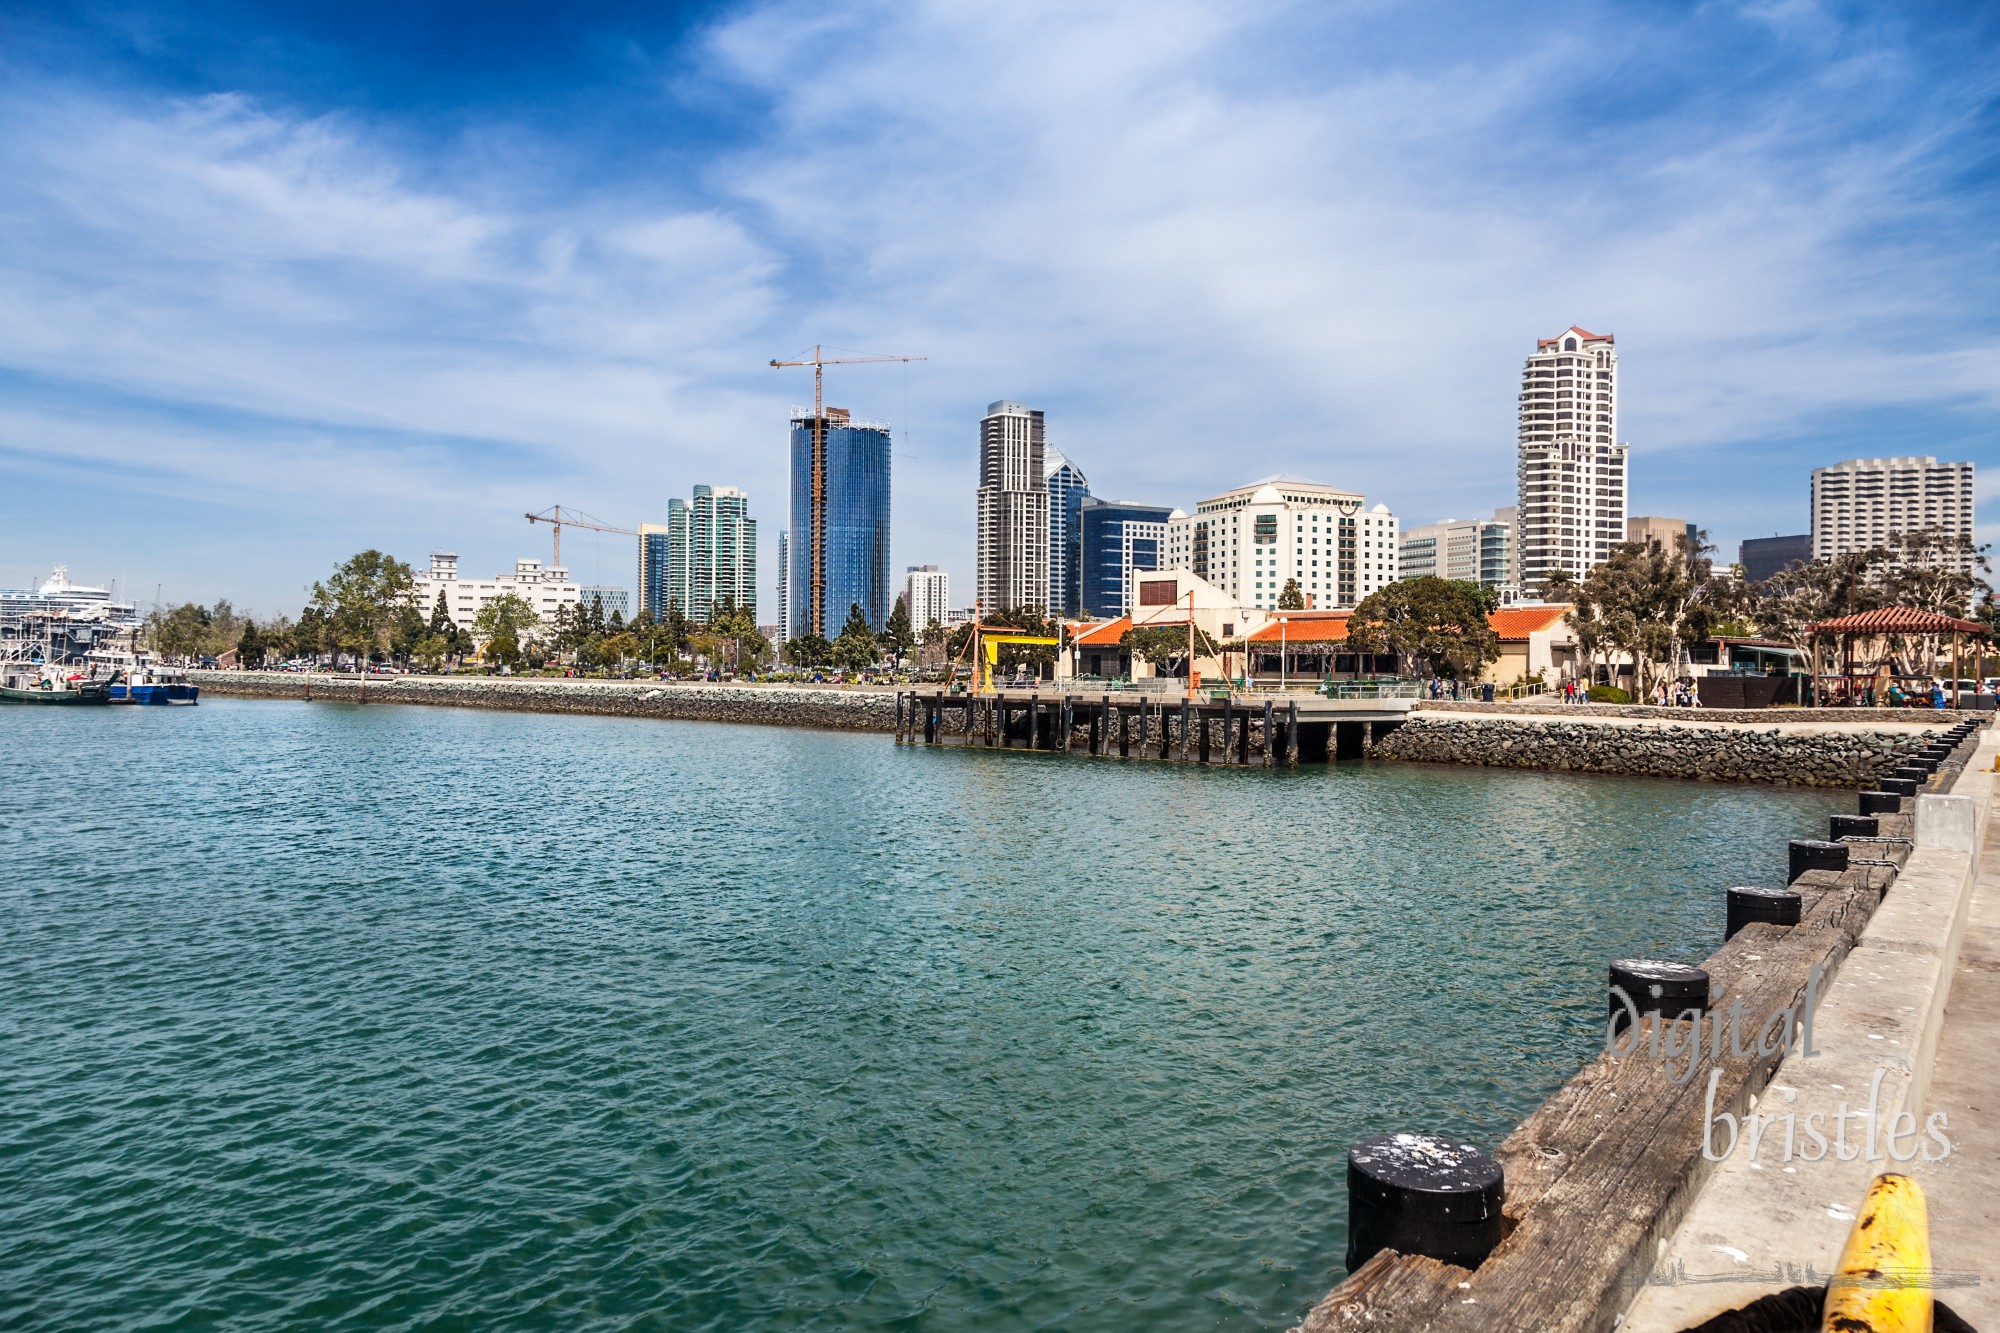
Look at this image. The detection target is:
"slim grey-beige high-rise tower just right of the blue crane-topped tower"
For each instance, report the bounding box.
[978,400,1050,610]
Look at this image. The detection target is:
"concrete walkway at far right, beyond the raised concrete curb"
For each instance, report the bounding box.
[1914,788,2000,1329]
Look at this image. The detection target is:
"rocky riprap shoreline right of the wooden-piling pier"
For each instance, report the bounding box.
[1374,709,1930,787]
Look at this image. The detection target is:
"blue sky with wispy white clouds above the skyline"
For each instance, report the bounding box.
[0,0,2000,618]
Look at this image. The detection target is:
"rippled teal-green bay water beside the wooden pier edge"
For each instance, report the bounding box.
[0,701,1846,1329]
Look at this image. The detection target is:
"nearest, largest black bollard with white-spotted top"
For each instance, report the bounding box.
[1348,1135,1506,1273]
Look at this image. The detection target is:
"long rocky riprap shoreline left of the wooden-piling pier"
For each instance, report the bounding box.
[194,671,896,733]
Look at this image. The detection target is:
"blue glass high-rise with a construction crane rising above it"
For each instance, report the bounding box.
[786,408,894,638]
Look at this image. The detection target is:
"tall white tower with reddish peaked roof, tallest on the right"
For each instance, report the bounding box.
[1514,324,1630,592]
